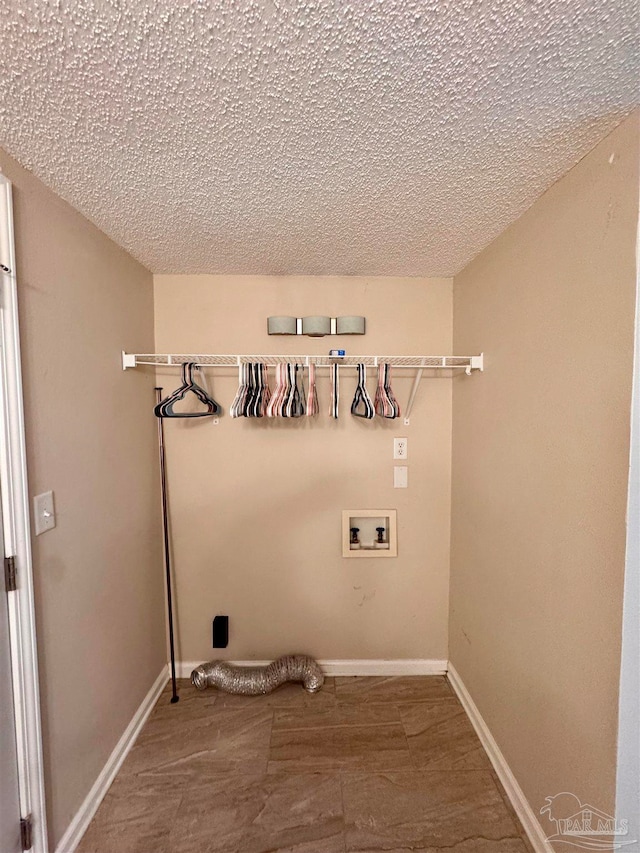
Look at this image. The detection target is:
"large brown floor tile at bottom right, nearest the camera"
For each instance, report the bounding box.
[342,770,521,853]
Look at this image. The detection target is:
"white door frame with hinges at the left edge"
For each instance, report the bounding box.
[0,175,48,853]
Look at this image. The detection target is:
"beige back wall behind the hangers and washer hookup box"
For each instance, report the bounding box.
[155,276,451,661]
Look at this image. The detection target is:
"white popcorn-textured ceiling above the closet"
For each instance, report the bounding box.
[0,0,639,275]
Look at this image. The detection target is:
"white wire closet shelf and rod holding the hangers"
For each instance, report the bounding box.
[122,352,484,374]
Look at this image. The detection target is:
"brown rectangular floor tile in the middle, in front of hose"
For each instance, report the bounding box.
[269,723,412,773]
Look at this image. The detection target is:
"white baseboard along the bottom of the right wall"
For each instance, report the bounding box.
[448,662,554,853]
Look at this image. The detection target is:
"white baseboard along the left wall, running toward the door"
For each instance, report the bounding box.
[55,666,169,853]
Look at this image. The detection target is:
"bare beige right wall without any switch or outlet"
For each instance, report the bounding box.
[450,115,638,829]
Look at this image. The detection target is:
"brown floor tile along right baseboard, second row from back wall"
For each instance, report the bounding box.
[399,698,491,770]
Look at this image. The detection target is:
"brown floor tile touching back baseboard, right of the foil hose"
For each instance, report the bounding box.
[335,675,454,702]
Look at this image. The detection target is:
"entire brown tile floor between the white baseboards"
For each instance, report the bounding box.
[77,676,531,853]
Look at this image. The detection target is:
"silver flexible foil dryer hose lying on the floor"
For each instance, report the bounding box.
[191,655,324,696]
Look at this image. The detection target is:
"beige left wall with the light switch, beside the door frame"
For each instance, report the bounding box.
[0,152,166,849]
